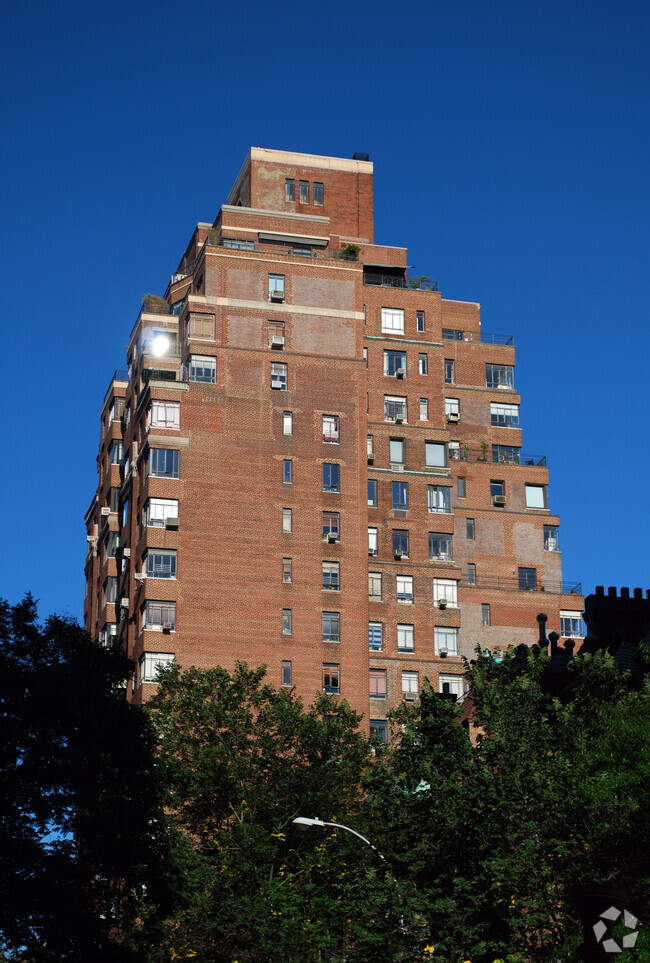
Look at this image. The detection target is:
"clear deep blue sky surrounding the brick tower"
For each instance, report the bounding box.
[0,0,650,616]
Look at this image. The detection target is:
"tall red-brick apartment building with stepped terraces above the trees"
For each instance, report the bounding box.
[85,148,583,732]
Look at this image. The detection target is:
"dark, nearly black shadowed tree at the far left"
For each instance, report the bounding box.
[0,596,165,963]
